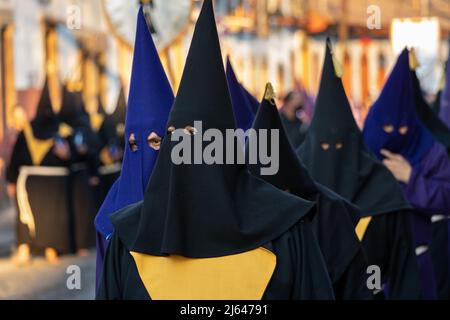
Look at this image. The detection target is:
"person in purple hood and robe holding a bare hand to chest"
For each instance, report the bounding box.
[364,49,450,299]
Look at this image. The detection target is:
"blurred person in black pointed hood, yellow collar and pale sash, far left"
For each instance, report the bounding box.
[6,81,71,254]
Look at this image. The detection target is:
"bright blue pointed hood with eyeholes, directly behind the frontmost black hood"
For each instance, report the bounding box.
[95,7,174,237]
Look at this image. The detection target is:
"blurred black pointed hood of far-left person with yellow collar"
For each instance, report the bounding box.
[31,79,59,140]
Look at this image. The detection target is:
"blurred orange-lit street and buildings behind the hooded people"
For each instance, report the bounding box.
[0,0,450,299]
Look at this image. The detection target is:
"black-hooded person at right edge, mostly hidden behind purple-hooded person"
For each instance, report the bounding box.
[409,51,450,300]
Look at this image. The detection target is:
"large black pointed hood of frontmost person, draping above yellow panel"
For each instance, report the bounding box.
[112,0,313,258]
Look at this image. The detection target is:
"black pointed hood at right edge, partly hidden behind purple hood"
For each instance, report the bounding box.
[411,57,450,150]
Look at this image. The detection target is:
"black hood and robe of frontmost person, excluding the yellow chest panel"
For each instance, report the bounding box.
[97,0,333,299]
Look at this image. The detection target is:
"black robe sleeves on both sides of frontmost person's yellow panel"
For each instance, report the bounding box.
[96,209,334,300]
